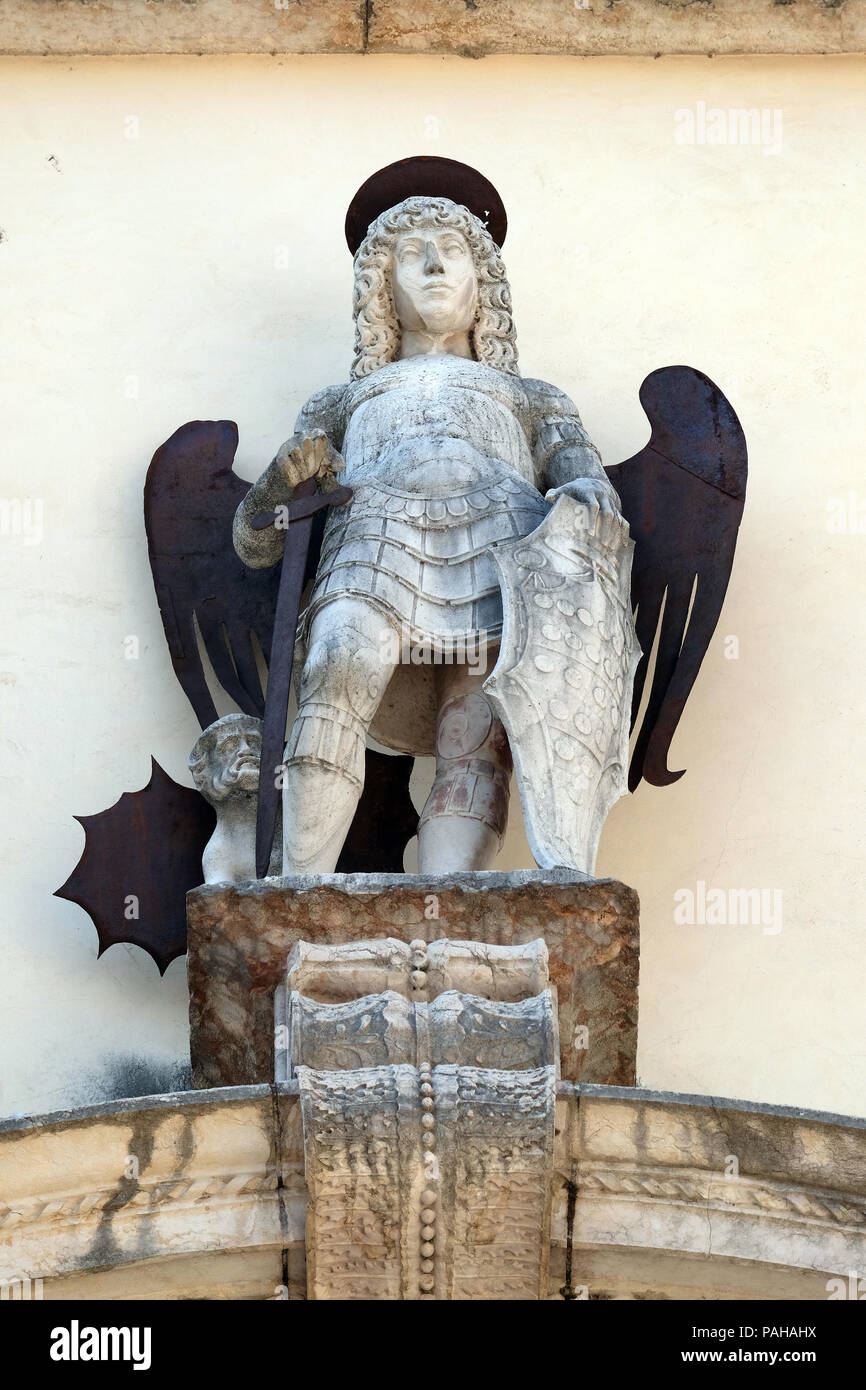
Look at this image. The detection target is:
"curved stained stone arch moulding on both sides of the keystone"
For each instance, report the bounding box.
[0,1083,866,1298]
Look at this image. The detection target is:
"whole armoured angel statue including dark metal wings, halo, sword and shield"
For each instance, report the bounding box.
[55,158,746,967]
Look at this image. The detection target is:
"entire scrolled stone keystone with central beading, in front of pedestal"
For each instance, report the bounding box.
[275,940,559,1300]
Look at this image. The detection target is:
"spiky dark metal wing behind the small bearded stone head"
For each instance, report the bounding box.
[54,758,217,974]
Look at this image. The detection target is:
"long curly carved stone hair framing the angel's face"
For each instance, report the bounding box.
[352,197,520,378]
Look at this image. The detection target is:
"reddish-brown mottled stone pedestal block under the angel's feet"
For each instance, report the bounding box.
[188,870,638,1087]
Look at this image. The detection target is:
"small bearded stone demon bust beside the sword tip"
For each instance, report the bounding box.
[189,714,282,883]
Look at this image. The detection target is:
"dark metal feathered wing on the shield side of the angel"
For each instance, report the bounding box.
[607,367,748,791]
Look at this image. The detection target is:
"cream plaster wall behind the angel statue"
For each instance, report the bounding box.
[0,57,866,1113]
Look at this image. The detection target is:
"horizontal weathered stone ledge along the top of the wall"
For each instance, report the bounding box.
[0,0,866,57]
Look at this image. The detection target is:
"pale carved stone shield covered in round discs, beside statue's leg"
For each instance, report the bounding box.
[484,496,641,874]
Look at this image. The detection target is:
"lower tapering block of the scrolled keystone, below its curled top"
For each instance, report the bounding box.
[297,1063,556,1301]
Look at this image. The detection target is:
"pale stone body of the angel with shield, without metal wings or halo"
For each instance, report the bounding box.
[234,196,638,874]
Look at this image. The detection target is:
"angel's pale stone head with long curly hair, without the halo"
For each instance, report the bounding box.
[352,197,517,377]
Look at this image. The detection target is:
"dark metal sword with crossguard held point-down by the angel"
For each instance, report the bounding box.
[252,478,352,878]
